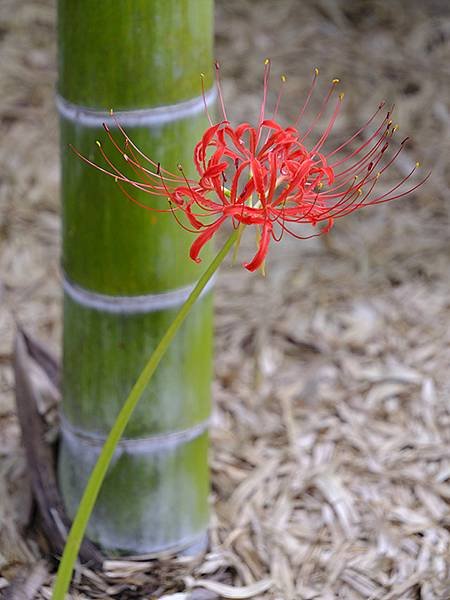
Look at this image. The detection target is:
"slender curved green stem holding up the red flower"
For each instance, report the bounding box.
[52,230,238,600]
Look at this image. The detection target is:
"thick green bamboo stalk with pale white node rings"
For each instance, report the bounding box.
[58,0,212,553]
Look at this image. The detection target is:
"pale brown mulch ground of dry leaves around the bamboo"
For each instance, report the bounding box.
[0,0,450,600]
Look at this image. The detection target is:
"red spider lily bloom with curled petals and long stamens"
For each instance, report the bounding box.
[77,61,426,271]
